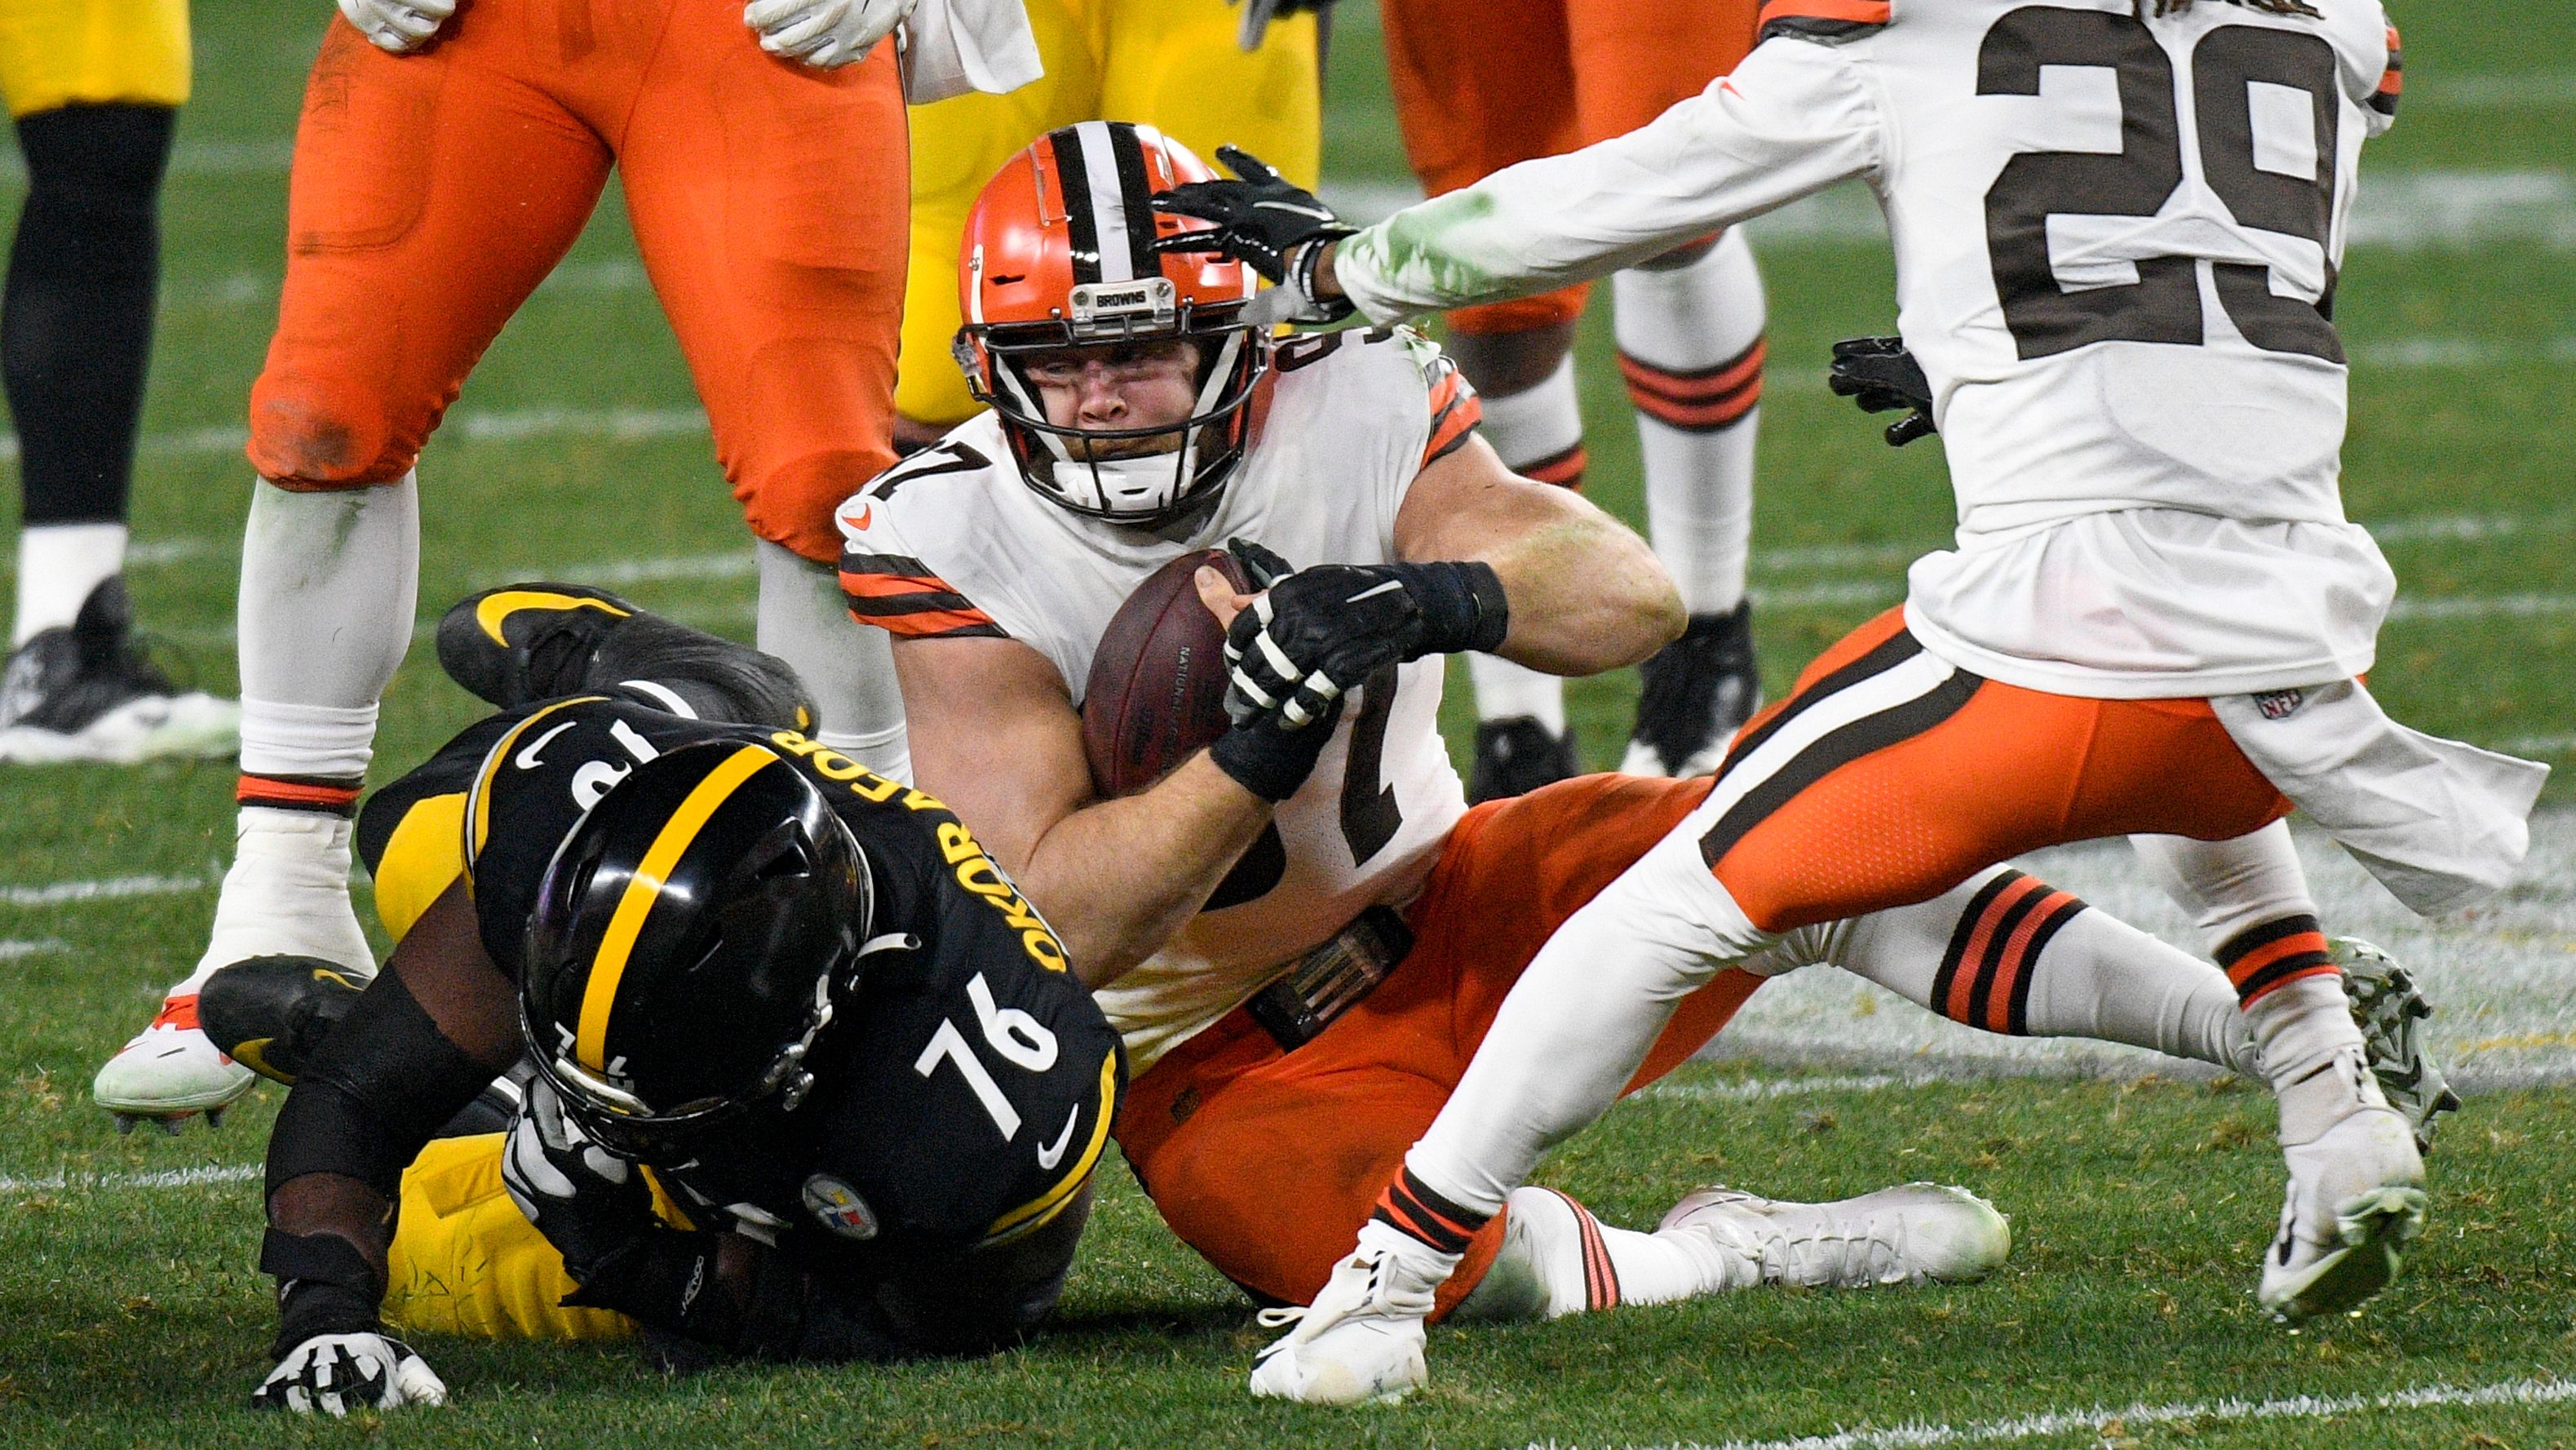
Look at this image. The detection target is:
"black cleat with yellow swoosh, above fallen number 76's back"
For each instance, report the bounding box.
[438,582,821,734]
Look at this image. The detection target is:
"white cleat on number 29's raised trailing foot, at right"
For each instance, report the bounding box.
[2254,1105,2427,1324]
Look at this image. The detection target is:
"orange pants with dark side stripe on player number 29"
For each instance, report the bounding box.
[1700,608,2290,933]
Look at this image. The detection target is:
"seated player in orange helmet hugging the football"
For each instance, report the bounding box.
[840,121,2432,1349]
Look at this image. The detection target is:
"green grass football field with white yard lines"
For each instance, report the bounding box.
[0,0,2576,1450]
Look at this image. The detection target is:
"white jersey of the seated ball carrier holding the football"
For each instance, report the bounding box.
[840,330,1476,1074]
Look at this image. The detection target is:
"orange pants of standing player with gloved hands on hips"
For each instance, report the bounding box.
[250,0,910,561]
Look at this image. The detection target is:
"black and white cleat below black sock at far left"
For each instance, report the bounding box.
[0,577,242,765]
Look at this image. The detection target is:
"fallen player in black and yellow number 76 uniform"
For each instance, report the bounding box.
[234,584,1123,1414]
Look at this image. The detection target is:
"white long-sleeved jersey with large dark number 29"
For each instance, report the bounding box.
[1334,0,2398,695]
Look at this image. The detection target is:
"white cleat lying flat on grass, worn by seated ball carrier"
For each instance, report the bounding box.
[1659,1182,2012,1288]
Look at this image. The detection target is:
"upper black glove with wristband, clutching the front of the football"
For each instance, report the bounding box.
[1226,551,1512,729]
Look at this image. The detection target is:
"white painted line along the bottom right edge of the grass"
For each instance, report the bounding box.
[1530,1381,2576,1450]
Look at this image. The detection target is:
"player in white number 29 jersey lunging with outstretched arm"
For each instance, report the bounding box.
[1159,0,2545,1401]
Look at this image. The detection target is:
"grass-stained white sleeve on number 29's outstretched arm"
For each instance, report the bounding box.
[1334,36,1878,322]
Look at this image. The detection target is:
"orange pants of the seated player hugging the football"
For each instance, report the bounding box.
[1118,775,1762,1311]
